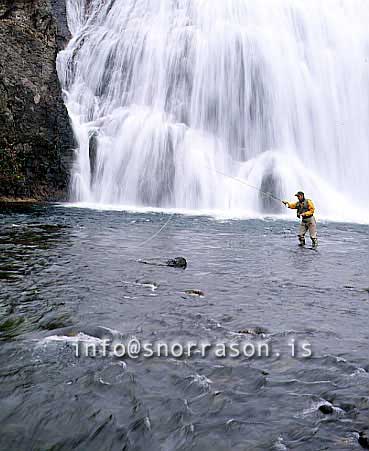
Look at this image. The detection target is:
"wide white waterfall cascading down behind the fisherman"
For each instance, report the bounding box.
[58,0,369,220]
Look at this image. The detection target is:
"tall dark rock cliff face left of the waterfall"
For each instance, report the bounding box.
[0,0,74,200]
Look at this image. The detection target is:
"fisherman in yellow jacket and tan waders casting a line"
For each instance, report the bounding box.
[282,191,318,248]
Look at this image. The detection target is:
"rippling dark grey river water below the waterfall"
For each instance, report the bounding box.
[0,204,369,451]
